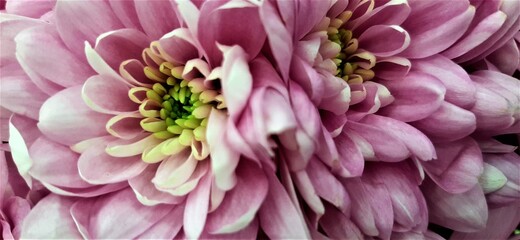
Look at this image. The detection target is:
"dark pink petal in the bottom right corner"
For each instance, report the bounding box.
[451,205,520,240]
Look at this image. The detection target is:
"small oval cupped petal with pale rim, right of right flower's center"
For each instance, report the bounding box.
[358,25,410,57]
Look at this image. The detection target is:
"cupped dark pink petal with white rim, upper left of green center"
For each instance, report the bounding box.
[94,28,150,71]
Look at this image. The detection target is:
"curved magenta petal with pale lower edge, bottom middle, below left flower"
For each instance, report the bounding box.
[206,161,268,234]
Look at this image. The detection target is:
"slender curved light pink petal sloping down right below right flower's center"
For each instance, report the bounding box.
[362,115,436,161]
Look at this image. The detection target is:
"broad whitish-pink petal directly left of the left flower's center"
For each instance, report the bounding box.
[38,86,110,145]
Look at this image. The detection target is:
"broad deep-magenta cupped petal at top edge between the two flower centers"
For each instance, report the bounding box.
[198,1,266,67]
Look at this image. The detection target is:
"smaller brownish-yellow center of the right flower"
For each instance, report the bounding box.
[327,11,376,83]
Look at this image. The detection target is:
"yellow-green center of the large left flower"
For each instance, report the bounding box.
[136,62,217,145]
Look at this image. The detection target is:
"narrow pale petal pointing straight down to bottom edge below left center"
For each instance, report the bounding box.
[184,175,211,238]
